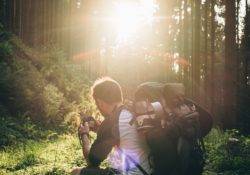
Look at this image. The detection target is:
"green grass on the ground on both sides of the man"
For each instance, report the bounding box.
[0,129,250,175]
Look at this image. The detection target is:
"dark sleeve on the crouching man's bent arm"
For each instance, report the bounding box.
[88,119,119,167]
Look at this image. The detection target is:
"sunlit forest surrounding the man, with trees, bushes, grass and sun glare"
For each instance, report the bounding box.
[0,0,250,175]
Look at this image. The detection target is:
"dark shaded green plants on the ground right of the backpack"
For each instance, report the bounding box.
[206,129,250,174]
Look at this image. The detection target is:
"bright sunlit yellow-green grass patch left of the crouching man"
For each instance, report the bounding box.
[0,135,85,175]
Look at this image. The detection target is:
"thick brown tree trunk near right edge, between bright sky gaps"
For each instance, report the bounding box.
[223,0,237,128]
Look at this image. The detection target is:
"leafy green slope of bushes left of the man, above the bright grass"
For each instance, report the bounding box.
[0,25,99,149]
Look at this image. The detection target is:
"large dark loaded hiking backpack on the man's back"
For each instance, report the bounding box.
[131,82,212,175]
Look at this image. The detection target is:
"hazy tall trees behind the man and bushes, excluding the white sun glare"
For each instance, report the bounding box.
[0,0,250,129]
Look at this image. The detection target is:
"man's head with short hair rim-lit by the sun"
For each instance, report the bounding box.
[91,77,123,116]
